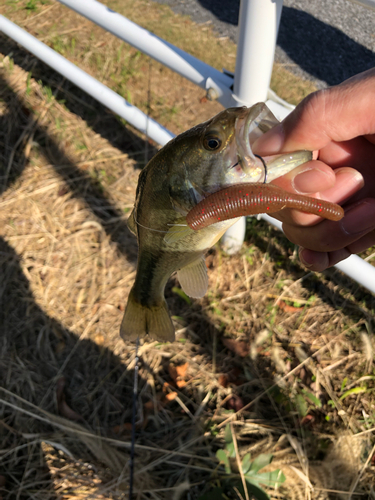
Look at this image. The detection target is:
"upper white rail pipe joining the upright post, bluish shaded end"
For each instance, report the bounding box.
[58,0,233,107]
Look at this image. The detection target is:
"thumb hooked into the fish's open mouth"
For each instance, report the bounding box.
[253,68,375,155]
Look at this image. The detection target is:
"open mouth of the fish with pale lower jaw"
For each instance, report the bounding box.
[235,103,312,182]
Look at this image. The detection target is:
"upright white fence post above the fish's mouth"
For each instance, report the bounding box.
[234,0,283,106]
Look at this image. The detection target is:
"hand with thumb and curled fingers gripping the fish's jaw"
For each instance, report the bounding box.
[253,69,375,271]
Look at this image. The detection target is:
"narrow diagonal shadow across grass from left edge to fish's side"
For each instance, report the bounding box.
[0,69,137,262]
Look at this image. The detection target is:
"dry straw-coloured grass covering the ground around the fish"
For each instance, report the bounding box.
[0,0,375,500]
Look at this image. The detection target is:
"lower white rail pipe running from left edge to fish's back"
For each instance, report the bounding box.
[0,15,174,145]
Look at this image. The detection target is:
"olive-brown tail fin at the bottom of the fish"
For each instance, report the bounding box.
[120,291,175,342]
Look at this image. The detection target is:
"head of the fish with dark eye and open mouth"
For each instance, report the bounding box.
[170,103,312,211]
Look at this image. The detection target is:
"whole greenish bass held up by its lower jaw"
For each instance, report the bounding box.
[120,103,340,342]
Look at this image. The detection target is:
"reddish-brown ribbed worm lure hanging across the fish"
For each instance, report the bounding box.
[186,183,344,230]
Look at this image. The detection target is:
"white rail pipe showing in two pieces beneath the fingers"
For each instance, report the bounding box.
[260,214,375,293]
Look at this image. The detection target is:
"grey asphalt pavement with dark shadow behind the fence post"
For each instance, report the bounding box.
[155,0,375,88]
